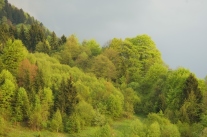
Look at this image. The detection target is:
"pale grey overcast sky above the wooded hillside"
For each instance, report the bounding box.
[8,0,207,78]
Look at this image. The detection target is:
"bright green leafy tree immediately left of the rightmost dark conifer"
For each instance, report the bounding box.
[162,68,190,122]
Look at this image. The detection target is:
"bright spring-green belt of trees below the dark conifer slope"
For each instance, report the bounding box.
[0,35,207,136]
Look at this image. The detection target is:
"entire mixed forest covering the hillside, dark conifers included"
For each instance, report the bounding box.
[0,0,207,137]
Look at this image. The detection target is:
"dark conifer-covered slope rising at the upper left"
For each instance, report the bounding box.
[0,0,66,54]
